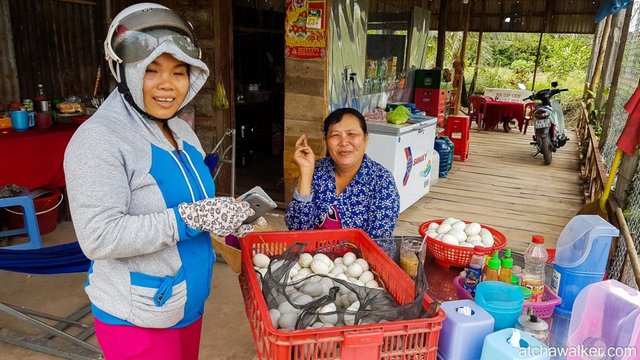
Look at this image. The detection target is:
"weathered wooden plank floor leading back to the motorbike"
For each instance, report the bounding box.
[395,125,584,251]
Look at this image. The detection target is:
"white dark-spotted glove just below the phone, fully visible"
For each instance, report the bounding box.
[178,197,254,236]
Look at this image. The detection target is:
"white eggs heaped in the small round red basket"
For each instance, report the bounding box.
[427,218,494,248]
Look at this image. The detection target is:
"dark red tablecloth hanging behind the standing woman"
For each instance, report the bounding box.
[0,123,78,190]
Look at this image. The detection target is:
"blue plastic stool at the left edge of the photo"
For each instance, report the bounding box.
[0,192,42,250]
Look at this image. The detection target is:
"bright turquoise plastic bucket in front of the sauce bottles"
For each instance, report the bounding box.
[475,281,524,331]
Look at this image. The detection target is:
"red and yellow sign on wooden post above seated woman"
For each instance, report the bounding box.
[284,0,327,59]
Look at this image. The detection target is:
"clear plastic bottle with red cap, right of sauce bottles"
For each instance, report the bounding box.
[522,235,549,302]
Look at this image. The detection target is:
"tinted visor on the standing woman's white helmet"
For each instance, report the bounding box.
[111,9,200,63]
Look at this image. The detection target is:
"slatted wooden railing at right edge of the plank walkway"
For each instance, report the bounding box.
[577,103,611,210]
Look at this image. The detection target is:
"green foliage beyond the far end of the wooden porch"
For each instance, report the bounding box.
[426,32,592,126]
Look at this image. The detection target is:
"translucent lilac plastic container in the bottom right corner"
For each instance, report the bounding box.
[567,280,640,360]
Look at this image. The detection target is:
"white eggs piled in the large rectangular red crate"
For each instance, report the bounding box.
[253,252,381,330]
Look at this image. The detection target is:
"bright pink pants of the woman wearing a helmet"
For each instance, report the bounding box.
[95,318,202,360]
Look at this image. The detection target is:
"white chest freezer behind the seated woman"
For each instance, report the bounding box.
[366,117,437,212]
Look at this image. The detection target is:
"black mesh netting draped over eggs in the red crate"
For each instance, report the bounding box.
[262,243,437,330]
